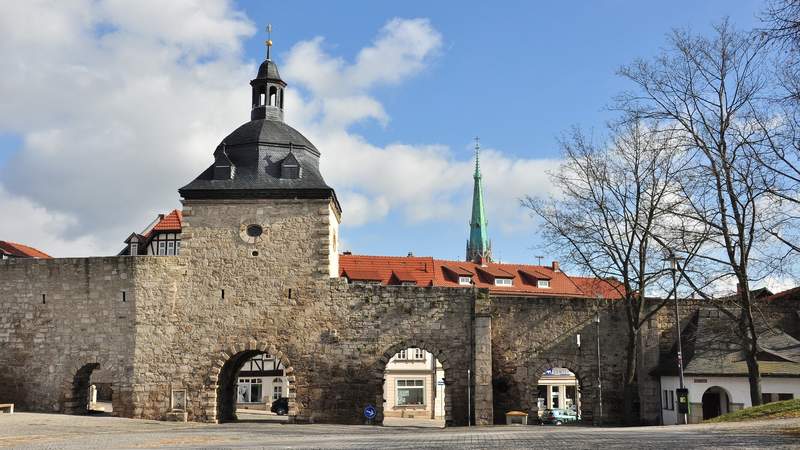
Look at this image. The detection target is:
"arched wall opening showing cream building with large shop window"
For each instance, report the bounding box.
[383,347,447,427]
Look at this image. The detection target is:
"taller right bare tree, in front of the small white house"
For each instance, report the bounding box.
[618,21,776,405]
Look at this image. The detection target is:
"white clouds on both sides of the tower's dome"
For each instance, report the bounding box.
[0,0,555,256]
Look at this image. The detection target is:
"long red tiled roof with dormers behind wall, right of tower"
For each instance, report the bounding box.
[339,254,621,299]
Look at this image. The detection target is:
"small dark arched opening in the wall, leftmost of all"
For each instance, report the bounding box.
[64,363,114,415]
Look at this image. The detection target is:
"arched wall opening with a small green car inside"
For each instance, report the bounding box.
[533,367,581,425]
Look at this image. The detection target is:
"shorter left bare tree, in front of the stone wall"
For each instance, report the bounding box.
[523,116,677,421]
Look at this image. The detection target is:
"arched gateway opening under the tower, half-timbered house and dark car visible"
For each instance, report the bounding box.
[217,350,295,422]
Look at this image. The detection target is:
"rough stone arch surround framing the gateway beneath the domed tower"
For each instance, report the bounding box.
[202,340,300,423]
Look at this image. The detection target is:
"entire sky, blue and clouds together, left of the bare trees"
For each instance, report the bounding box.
[0,0,763,262]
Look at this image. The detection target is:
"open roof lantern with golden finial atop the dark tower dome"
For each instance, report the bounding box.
[250,25,286,122]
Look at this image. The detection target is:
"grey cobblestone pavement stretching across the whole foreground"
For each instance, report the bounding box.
[0,413,800,449]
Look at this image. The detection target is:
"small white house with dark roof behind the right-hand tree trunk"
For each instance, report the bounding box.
[653,309,800,425]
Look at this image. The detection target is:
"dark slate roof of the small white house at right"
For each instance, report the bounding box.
[651,308,800,377]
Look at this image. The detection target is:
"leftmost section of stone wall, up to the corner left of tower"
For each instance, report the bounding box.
[0,257,137,416]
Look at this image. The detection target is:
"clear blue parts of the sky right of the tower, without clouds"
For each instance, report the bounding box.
[239,0,761,262]
